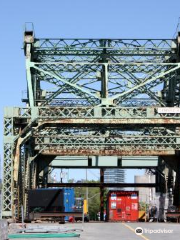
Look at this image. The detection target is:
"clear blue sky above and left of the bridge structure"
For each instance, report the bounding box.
[0,0,180,181]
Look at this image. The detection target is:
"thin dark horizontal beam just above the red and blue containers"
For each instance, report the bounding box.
[47,183,156,188]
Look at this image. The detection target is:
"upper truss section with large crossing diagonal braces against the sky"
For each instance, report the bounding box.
[25,32,180,106]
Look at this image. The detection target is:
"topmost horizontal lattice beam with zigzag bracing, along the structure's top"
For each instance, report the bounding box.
[31,39,177,57]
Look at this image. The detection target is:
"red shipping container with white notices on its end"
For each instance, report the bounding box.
[107,191,139,221]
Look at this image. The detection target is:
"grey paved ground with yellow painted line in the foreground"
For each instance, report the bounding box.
[8,223,180,240]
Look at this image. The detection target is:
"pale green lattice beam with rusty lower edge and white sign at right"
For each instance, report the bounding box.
[8,106,180,121]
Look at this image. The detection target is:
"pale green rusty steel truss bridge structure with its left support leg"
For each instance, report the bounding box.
[3,27,180,217]
